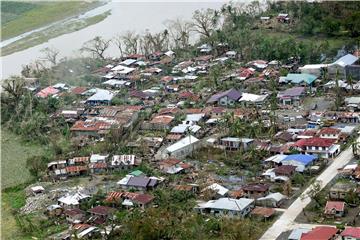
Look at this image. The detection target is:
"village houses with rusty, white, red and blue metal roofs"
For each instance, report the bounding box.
[20,32,360,239]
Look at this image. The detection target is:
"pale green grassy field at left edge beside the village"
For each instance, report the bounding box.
[1,129,44,189]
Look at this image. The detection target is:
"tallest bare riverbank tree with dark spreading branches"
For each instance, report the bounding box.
[192,8,219,38]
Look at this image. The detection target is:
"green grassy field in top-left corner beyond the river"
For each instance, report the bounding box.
[1,1,101,40]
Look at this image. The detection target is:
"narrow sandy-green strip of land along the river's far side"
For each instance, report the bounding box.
[1,12,110,56]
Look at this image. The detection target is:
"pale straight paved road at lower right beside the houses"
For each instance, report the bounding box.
[260,137,360,240]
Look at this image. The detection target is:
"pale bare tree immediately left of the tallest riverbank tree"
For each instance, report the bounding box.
[166,18,193,48]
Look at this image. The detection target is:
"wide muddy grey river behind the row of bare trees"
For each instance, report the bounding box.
[0,1,224,79]
